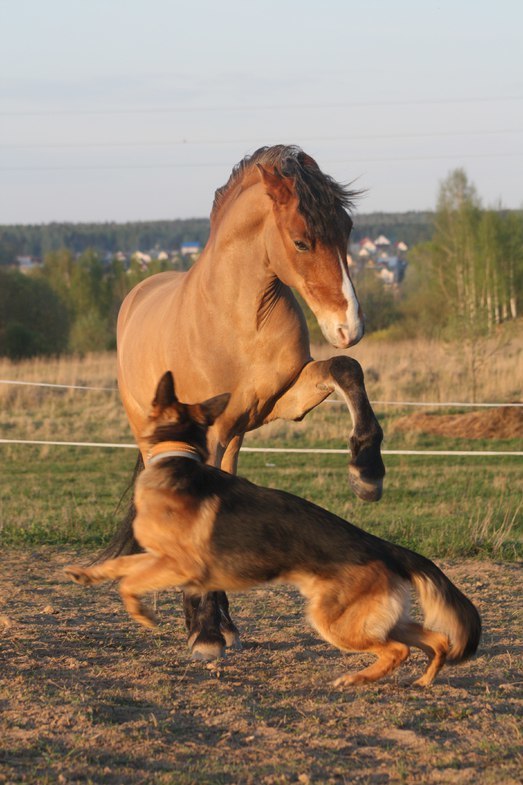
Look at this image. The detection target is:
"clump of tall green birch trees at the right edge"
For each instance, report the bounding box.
[404,169,523,401]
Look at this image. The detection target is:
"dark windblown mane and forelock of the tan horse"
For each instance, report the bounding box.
[211,144,360,245]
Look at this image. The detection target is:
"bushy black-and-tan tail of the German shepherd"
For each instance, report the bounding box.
[401,549,481,663]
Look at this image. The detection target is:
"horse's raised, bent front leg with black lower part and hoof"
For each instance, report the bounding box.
[265,355,385,501]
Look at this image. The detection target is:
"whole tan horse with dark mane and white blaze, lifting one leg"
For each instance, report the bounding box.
[112,145,385,659]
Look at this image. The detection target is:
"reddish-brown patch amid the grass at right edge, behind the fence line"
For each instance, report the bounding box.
[392,406,523,439]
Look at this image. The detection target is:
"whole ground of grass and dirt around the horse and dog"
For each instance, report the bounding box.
[0,341,523,785]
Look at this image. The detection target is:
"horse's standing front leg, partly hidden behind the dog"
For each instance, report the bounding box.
[183,435,243,660]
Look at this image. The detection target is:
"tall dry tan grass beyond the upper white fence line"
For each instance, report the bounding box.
[0,323,523,404]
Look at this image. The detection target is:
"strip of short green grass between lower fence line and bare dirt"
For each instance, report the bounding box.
[0,437,522,561]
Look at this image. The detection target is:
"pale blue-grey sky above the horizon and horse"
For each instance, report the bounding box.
[0,0,523,224]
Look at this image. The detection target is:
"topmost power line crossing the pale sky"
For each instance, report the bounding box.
[0,95,523,117]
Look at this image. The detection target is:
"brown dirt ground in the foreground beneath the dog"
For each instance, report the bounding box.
[0,548,523,785]
